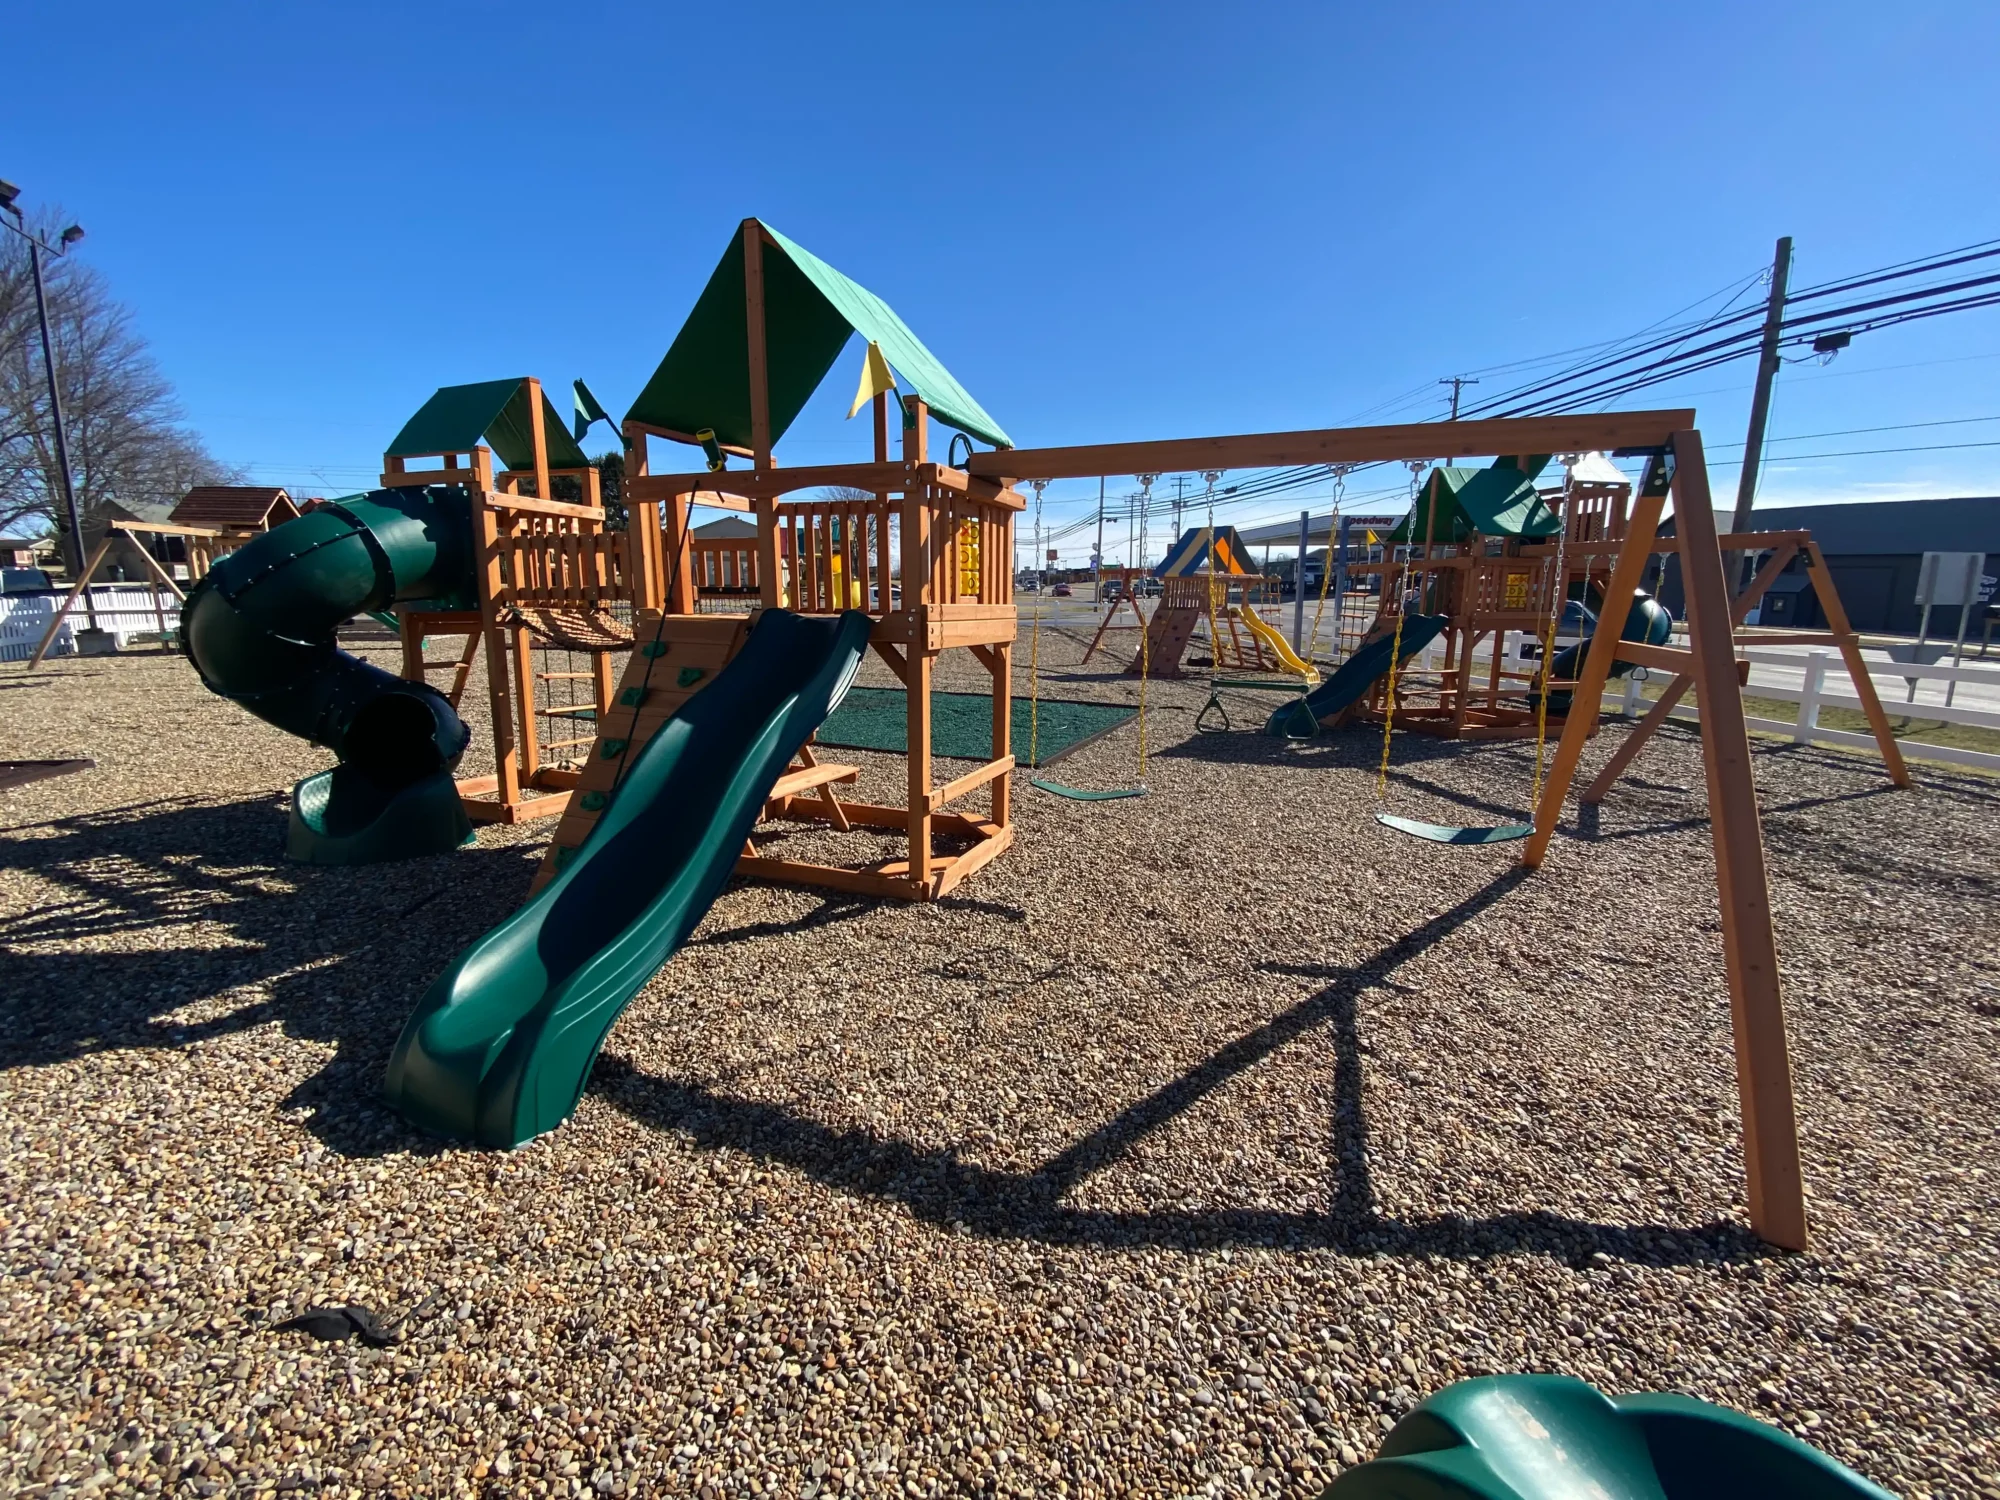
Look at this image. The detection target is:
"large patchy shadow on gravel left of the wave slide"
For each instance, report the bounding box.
[0,796,540,1154]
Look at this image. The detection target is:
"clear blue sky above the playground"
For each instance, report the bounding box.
[0,0,2000,564]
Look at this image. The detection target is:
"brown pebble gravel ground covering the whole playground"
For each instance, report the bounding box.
[0,636,2000,1496]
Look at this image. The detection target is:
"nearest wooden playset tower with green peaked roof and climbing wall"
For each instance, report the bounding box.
[520,218,1026,900]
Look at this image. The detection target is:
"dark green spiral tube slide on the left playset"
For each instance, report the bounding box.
[180,486,484,864]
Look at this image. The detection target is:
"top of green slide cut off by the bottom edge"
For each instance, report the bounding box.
[1320,1374,1894,1500]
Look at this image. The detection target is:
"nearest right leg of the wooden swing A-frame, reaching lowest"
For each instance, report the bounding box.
[1664,432,1808,1250]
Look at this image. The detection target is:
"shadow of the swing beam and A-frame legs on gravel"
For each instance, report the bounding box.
[590,868,1776,1266]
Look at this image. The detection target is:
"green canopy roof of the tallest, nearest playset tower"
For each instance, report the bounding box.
[626,224,1014,448]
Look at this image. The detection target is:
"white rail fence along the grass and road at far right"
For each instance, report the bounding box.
[1624,650,2000,770]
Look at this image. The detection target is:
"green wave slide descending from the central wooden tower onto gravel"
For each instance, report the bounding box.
[388,610,870,1146]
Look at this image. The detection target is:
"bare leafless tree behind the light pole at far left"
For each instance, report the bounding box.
[0,214,246,560]
